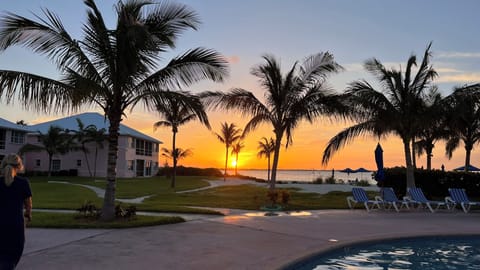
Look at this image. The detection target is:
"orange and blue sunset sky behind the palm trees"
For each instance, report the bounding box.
[0,0,480,169]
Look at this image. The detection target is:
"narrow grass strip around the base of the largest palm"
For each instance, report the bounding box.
[27,212,185,229]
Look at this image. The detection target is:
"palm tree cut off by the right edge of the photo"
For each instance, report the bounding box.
[446,84,480,172]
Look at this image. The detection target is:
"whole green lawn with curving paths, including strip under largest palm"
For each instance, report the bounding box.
[30,176,375,228]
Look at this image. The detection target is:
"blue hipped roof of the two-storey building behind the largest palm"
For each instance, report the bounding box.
[28,112,162,143]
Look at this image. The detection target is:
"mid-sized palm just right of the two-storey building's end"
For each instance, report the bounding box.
[153,92,210,188]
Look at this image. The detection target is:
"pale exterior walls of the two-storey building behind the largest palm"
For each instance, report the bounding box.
[25,134,158,178]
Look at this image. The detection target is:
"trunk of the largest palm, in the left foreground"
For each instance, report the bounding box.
[101,113,122,221]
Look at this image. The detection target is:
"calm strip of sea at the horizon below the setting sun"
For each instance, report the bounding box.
[228,170,376,184]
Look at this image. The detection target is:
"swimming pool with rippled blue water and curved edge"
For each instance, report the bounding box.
[286,236,480,270]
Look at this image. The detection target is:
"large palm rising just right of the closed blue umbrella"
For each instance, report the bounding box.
[322,43,437,188]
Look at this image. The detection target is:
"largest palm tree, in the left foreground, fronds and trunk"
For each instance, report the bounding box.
[0,0,228,220]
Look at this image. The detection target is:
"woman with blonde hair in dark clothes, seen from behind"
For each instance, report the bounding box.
[0,154,32,270]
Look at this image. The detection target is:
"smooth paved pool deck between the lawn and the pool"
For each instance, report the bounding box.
[17,209,480,270]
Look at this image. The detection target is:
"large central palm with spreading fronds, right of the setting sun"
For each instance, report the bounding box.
[203,52,343,190]
